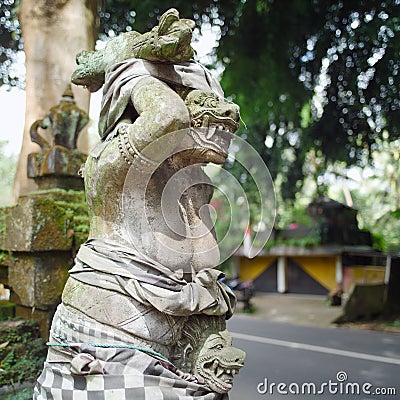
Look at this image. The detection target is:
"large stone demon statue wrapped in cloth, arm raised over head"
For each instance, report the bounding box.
[34,9,245,400]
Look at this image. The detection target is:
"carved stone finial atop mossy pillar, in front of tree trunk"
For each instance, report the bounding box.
[28,85,89,190]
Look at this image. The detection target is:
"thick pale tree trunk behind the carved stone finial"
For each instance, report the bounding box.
[13,0,97,201]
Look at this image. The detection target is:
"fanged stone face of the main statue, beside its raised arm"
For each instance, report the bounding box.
[185,90,240,164]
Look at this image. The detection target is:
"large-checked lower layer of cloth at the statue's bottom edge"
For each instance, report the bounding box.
[33,348,228,400]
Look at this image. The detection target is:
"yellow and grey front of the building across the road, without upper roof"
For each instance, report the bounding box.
[235,245,390,295]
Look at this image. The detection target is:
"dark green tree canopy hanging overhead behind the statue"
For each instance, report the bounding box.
[0,0,400,203]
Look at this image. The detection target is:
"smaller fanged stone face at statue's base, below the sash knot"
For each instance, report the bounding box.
[194,330,245,393]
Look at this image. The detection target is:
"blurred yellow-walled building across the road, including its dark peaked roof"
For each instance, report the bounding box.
[235,196,391,294]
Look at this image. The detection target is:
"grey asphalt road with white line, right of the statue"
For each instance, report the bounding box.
[228,316,400,400]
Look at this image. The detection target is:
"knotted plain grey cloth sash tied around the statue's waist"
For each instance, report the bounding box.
[70,239,236,319]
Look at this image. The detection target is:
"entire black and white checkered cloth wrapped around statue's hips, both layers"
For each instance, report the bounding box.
[33,305,228,400]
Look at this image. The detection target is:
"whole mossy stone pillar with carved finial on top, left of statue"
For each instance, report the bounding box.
[0,87,89,338]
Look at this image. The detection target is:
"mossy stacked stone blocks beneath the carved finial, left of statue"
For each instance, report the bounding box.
[0,189,89,337]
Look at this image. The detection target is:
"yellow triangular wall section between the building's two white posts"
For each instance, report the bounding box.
[290,256,336,290]
